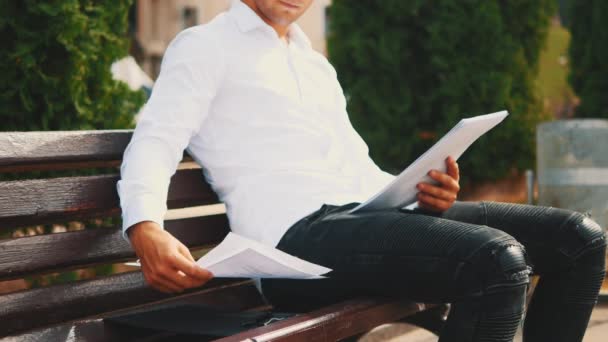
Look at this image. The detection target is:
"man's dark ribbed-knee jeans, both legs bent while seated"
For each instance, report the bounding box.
[262,202,606,342]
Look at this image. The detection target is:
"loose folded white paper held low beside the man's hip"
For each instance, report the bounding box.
[196,233,331,279]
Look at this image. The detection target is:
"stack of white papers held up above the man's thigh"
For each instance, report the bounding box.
[349,111,509,213]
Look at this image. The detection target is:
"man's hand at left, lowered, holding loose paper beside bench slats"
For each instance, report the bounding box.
[127,221,213,293]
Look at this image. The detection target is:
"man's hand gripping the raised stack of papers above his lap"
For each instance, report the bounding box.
[416,157,460,212]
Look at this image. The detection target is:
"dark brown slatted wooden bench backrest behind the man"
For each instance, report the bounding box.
[0,130,262,336]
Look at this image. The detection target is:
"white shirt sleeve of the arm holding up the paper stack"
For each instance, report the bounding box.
[331,67,396,196]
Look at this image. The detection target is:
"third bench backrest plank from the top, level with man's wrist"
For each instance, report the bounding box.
[0,215,230,280]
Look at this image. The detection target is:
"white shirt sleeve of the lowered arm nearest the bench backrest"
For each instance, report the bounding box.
[116,30,222,241]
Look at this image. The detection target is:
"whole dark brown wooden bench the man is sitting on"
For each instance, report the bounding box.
[0,130,447,341]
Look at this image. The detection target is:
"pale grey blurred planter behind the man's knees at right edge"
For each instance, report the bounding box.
[536,119,608,227]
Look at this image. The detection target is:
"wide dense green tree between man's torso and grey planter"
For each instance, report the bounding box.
[328,0,556,181]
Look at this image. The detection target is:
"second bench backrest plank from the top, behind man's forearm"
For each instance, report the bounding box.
[0,169,218,230]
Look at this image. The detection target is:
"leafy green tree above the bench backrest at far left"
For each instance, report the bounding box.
[0,0,145,130]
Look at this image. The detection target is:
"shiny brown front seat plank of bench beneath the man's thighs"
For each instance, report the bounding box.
[216,298,434,342]
